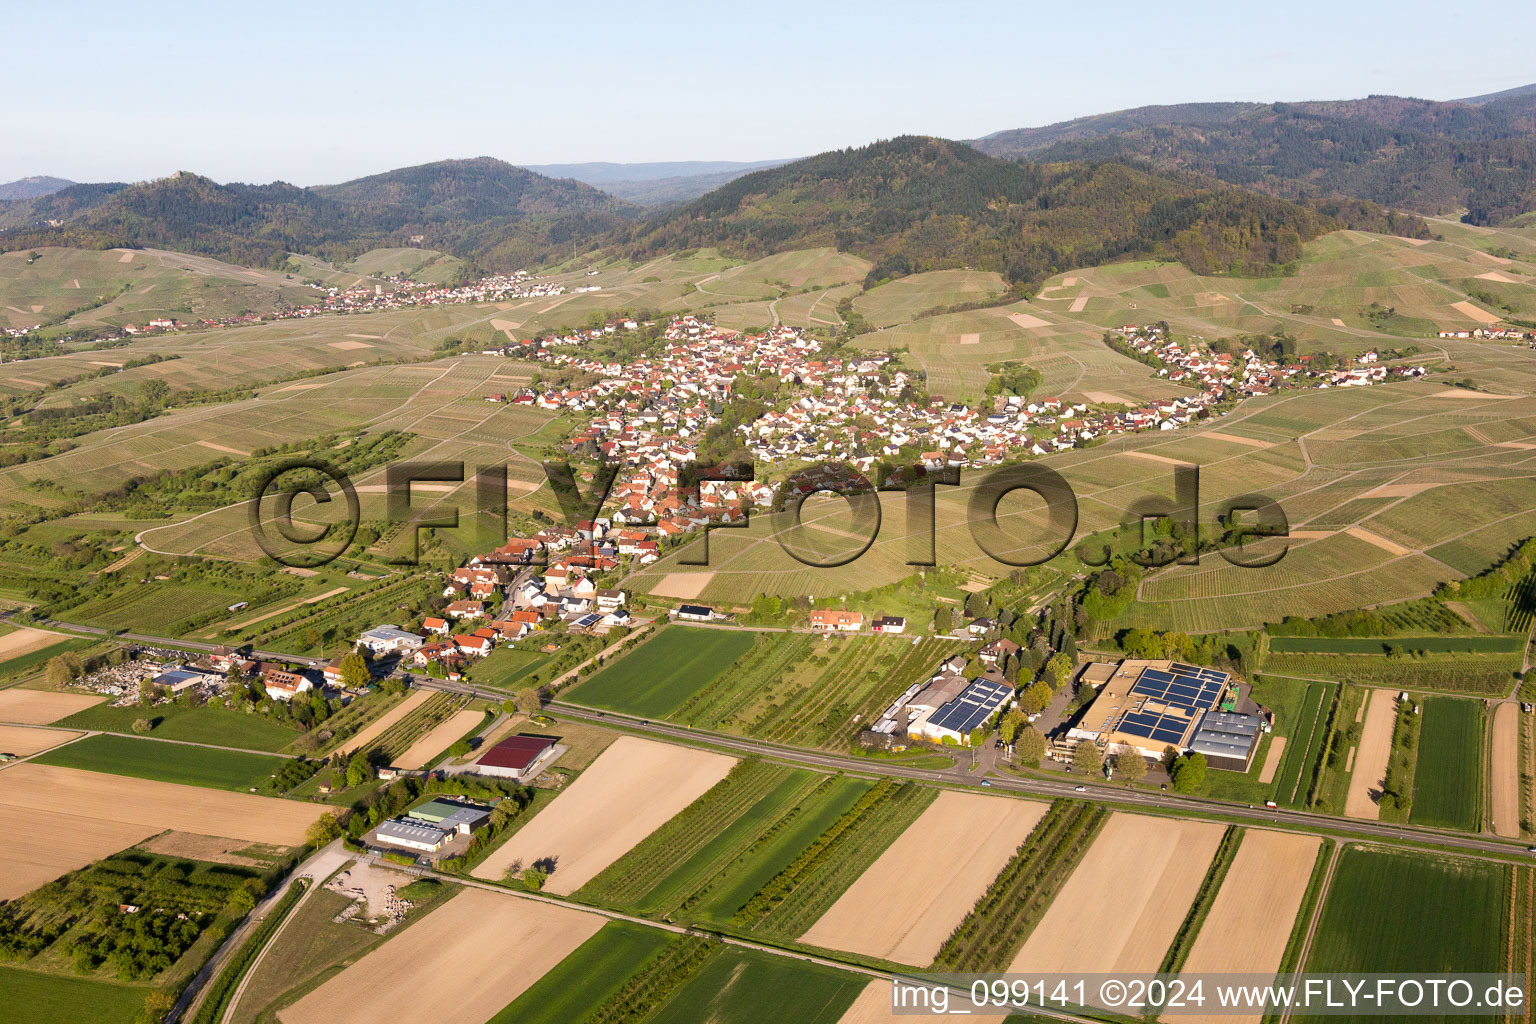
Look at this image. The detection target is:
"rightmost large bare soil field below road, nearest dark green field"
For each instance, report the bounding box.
[1175,829,1322,1024]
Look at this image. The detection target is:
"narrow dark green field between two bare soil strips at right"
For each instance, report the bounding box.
[1409,697,1482,832]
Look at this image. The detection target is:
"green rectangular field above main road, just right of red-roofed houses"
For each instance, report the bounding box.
[570,626,753,718]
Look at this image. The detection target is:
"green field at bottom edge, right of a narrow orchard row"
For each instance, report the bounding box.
[647,947,869,1024]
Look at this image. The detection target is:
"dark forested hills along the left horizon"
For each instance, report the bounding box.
[0,158,634,269]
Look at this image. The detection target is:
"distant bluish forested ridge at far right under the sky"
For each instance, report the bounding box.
[975,89,1536,224]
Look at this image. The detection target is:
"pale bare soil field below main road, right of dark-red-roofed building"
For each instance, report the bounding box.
[475,735,736,897]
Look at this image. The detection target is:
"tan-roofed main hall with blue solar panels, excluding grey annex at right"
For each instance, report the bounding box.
[1068,659,1230,758]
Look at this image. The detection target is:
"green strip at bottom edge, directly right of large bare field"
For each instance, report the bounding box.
[488,921,673,1024]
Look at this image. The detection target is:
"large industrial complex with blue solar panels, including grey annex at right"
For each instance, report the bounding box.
[1068,659,1264,771]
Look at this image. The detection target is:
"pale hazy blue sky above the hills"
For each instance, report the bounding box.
[12,0,1536,184]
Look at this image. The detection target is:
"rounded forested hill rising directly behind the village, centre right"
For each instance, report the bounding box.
[614,137,1427,284]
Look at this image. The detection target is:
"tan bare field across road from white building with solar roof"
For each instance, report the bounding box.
[800,791,1046,966]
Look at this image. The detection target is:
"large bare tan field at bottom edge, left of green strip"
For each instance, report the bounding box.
[278,889,604,1024]
